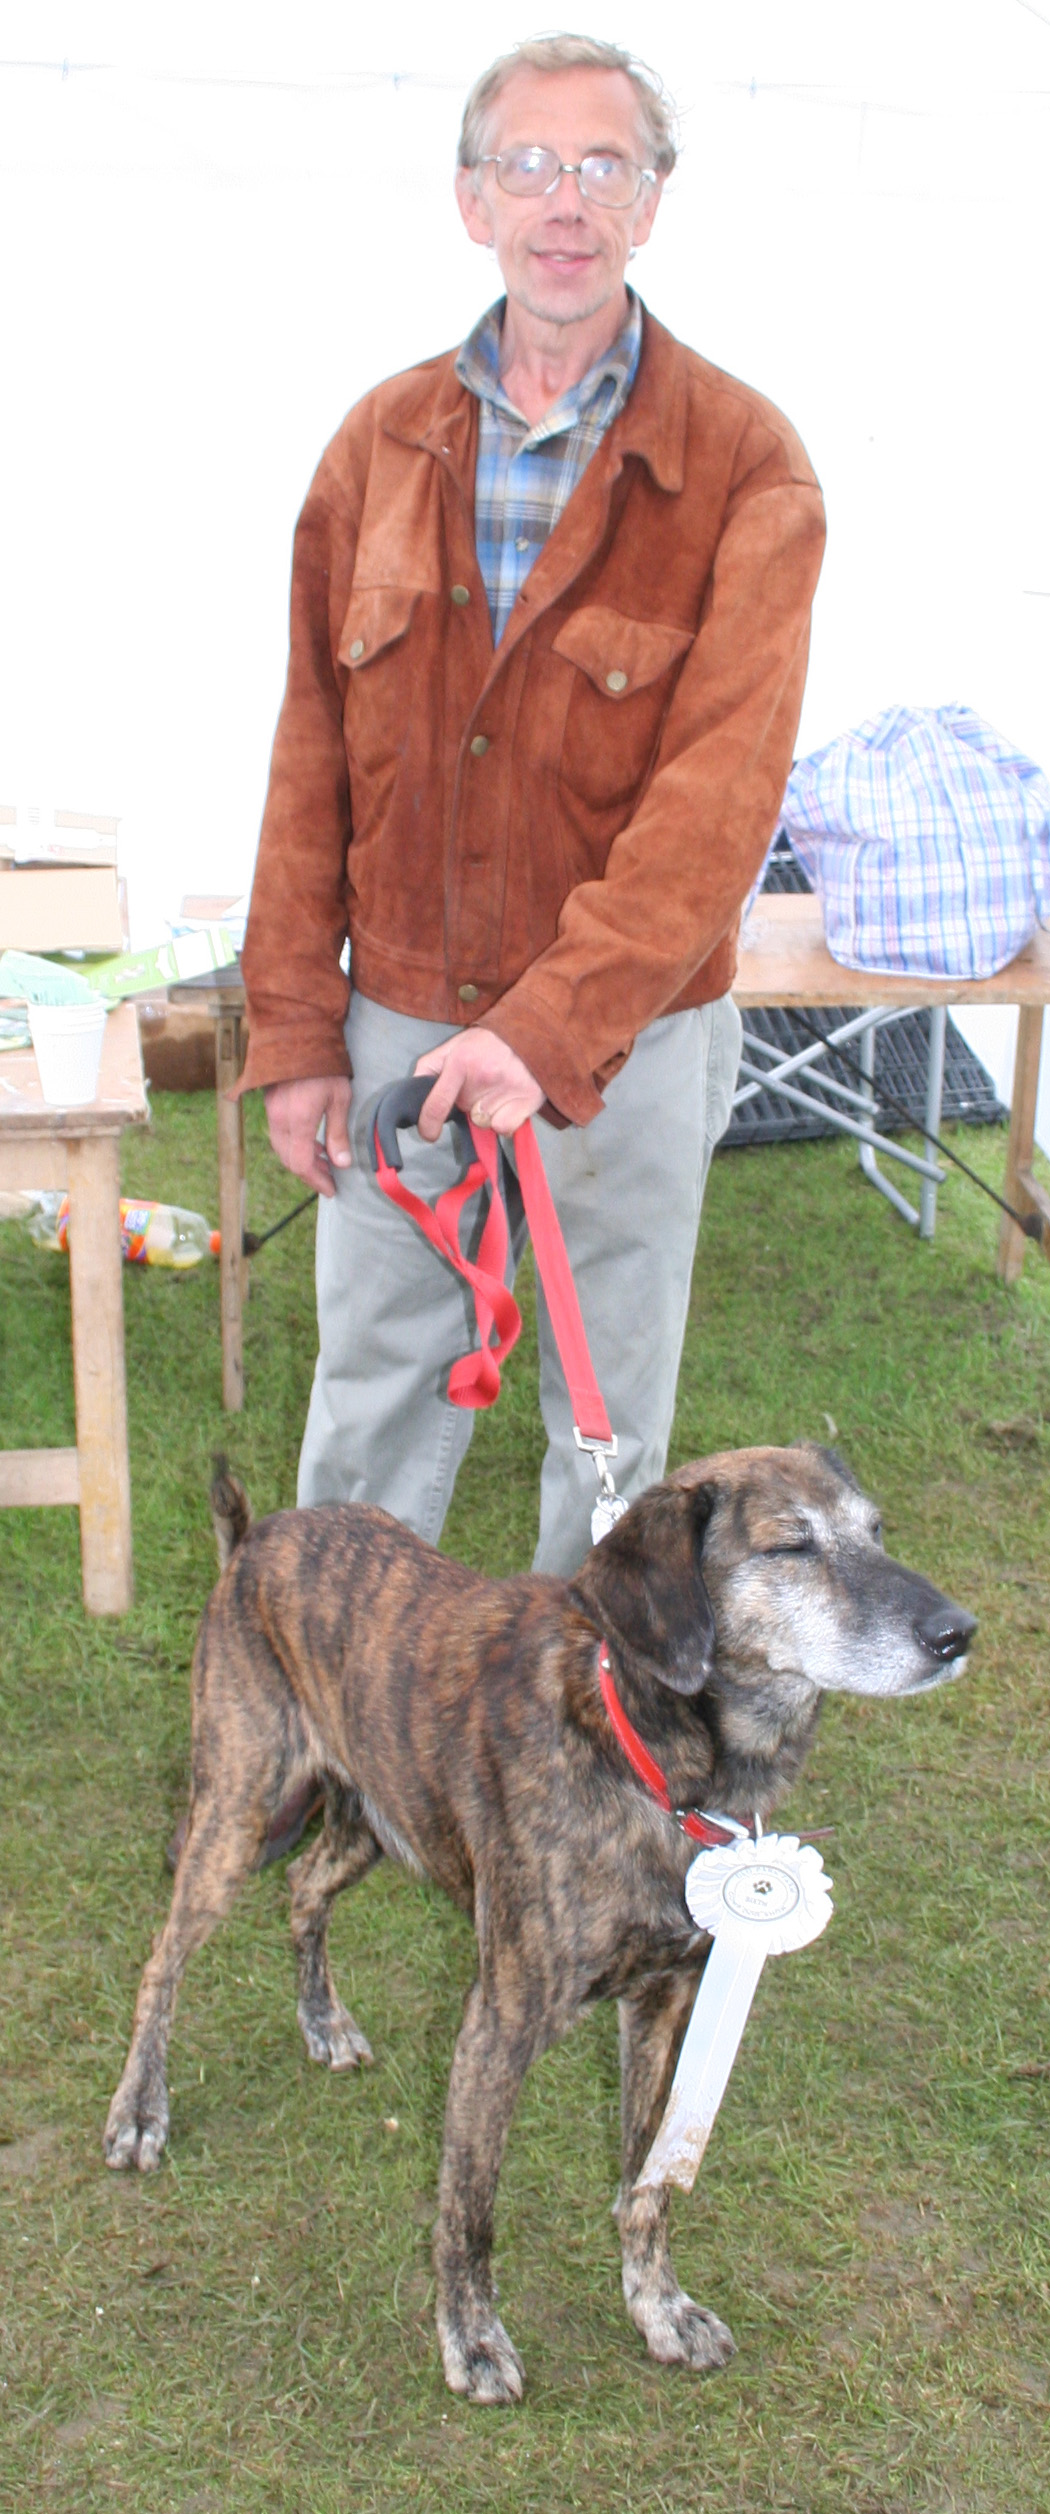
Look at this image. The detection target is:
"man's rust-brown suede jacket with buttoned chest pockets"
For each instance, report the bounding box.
[244,314,824,1126]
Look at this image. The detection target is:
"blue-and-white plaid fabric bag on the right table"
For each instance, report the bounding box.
[781,706,1050,978]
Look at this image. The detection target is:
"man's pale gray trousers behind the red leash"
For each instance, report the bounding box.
[299,996,741,1574]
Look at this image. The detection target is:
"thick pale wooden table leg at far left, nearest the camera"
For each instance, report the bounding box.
[68,1134,131,1614]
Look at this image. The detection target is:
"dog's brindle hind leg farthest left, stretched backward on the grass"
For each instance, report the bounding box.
[103,1775,271,2175]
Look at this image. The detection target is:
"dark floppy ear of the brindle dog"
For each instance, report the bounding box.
[573,1483,716,1694]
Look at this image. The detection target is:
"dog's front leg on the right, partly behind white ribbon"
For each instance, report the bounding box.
[615,1971,736,2373]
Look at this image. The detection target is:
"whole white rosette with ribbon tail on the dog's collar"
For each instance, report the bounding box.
[636,1833,831,2192]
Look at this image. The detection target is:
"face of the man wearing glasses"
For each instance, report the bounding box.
[455,70,663,324]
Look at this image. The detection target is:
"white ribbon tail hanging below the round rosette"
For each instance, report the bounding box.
[636,1928,766,2192]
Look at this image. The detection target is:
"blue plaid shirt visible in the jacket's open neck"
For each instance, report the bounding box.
[455,289,641,644]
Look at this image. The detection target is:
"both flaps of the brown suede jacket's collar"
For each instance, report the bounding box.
[382,309,686,495]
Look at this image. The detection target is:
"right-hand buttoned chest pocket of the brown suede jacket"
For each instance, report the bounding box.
[553,603,693,810]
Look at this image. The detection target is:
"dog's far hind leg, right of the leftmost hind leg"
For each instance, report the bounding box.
[289,1780,382,2069]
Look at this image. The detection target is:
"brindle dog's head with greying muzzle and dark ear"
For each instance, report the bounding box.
[573,1443,977,1704]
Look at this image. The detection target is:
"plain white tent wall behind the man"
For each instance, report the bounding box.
[0,0,1050,1144]
